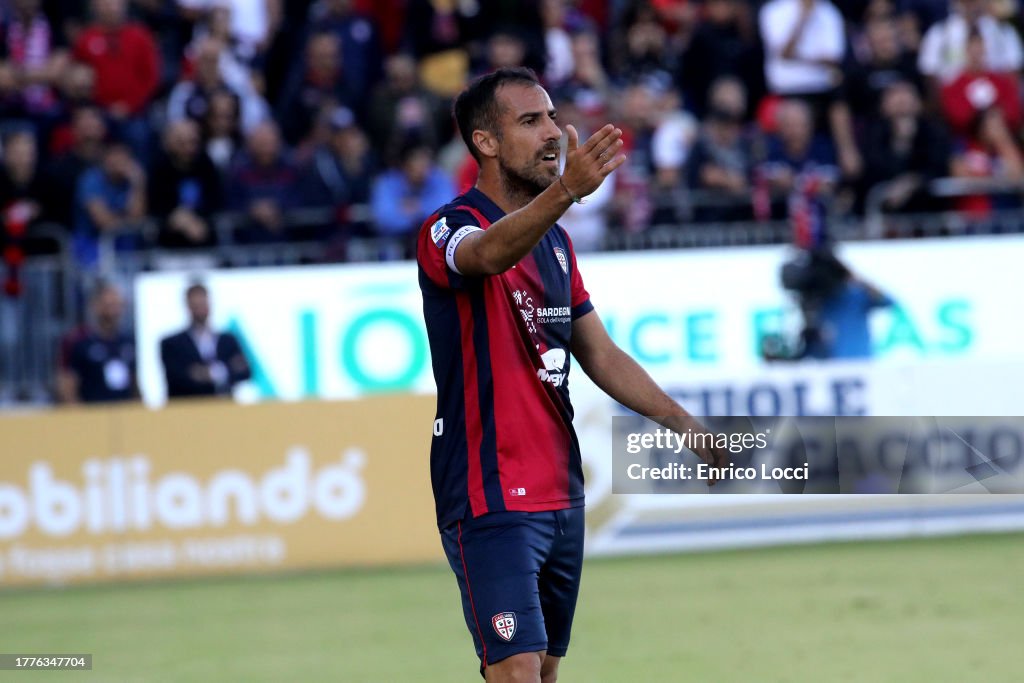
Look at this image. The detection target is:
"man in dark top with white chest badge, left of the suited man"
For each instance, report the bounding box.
[56,284,138,403]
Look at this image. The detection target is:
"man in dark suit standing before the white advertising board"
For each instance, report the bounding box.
[160,284,252,398]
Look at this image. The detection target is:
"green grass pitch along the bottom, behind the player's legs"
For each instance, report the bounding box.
[0,535,1024,683]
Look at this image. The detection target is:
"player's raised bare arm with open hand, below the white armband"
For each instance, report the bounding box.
[449,124,626,275]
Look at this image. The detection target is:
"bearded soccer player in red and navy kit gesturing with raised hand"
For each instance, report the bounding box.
[417,69,727,683]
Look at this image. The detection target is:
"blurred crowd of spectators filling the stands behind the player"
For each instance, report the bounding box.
[0,0,1024,278]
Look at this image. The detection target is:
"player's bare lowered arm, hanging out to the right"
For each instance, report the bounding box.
[572,310,729,479]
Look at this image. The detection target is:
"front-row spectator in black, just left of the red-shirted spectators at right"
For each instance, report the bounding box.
[864,81,949,212]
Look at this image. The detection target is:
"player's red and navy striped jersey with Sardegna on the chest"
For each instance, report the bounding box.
[417,187,593,528]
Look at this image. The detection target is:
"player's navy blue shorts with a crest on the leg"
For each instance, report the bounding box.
[441,507,584,672]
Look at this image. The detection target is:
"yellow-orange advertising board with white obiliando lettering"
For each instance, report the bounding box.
[0,395,442,587]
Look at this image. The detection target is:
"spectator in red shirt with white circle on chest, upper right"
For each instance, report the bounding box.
[942,30,1021,135]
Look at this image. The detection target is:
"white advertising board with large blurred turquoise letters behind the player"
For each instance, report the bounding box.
[135,237,1024,405]
